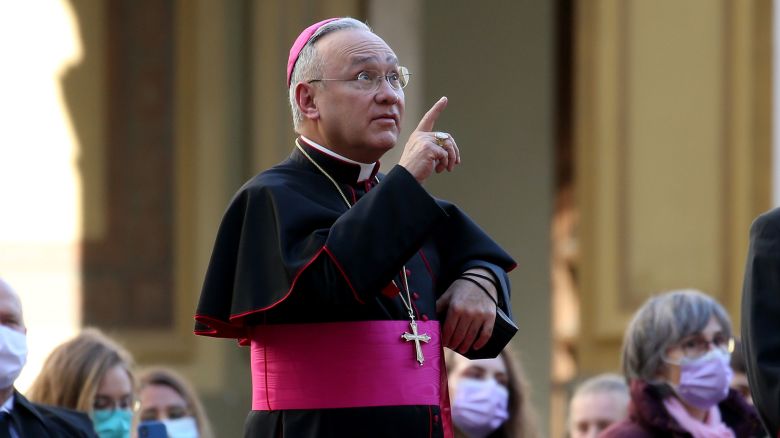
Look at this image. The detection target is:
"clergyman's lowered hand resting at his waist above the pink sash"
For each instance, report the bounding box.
[436,269,497,354]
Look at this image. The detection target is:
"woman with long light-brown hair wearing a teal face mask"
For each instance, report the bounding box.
[28,329,134,438]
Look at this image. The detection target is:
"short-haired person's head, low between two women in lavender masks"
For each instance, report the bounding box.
[568,373,629,438]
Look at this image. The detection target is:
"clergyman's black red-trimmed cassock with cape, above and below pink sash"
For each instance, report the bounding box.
[195,141,515,437]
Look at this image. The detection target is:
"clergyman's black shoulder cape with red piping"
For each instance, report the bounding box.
[195,160,515,340]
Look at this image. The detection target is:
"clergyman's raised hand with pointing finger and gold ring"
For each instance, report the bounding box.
[398,97,460,183]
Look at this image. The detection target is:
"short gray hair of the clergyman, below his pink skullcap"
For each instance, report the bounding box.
[289,17,373,131]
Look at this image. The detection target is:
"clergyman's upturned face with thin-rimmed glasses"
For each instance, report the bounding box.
[310,29,404,163]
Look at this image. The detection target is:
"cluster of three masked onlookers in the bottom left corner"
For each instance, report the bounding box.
[0,279,215,438]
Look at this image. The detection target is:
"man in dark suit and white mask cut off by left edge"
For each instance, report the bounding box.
[0,279,97,438]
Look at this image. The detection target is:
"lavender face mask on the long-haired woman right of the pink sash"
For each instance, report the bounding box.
[452,378,509,438]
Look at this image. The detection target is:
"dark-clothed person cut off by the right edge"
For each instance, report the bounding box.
[742,208,780,437]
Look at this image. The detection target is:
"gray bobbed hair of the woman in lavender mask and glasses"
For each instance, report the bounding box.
[622,289,731,383]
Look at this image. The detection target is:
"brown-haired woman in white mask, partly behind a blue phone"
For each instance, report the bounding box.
[133,367,214,438]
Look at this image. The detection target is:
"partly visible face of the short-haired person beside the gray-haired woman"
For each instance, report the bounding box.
[569,392,628,438]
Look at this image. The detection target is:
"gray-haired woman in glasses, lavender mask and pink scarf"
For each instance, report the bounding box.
[601,290,764,438]
